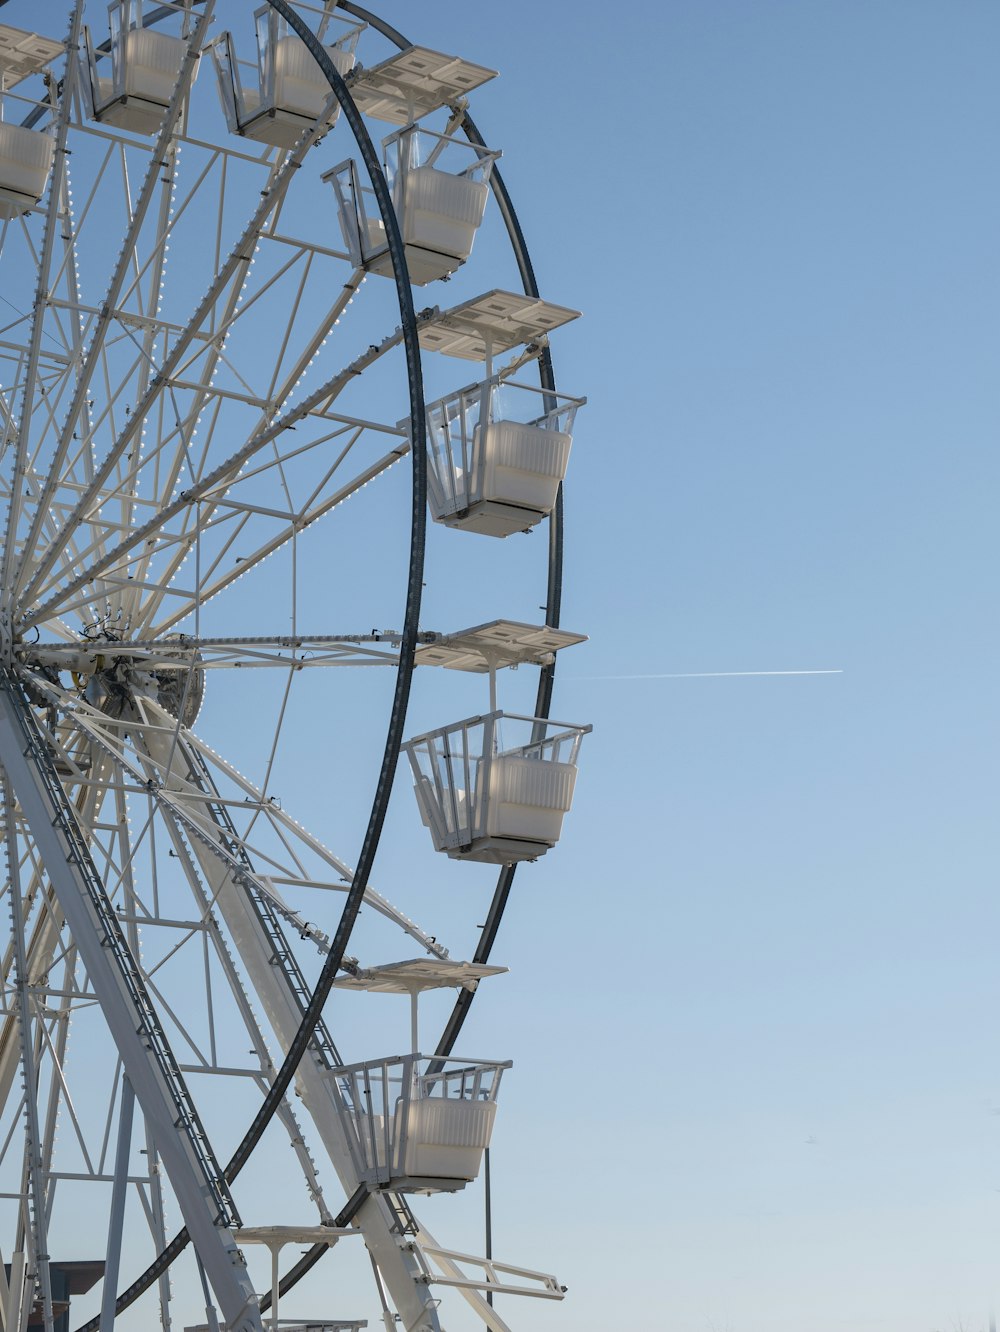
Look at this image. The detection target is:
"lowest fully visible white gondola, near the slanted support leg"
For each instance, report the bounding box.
[329,1054,510,1193]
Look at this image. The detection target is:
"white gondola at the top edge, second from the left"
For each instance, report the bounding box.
[83,0,198,135]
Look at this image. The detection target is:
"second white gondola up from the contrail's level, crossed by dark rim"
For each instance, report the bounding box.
[330,125,499,286]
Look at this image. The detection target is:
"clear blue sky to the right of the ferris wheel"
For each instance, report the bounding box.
[4,0,1000,1332]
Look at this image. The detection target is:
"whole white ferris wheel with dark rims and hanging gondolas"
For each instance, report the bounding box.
[0,0,590,1332]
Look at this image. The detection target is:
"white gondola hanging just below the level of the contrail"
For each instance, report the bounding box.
[403,711,591,864]
